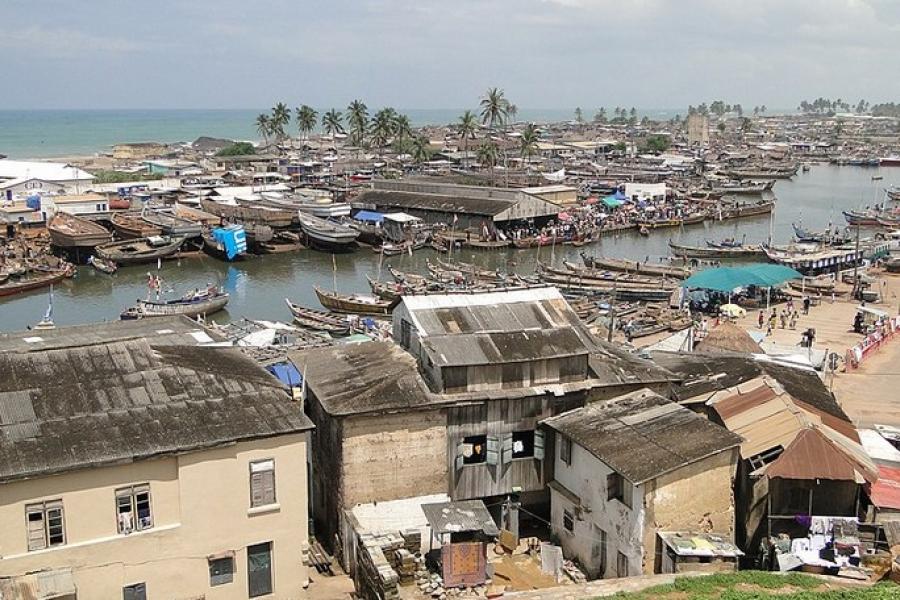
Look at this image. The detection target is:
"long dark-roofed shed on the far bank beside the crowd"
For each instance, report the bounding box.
[352,180,560,231]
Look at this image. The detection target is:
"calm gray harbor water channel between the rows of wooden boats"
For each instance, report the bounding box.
[0,165,900,332]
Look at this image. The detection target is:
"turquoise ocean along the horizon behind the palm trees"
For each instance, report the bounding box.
[0,107,685,159]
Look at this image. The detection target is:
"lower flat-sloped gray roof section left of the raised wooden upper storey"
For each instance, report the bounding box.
[289,341,442,416]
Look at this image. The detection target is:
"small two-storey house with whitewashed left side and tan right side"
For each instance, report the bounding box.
[542,389,741,578]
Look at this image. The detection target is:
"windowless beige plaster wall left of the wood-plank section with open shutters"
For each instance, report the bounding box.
[342,410,449,509]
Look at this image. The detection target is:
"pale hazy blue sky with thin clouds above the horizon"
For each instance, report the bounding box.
[0,0,900,111]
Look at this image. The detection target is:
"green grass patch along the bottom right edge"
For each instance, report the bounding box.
[614,571,900,600]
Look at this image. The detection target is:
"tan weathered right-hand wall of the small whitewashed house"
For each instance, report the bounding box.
[643,448,738,575]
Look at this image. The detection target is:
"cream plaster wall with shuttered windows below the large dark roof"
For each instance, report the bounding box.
[0,434,307,600]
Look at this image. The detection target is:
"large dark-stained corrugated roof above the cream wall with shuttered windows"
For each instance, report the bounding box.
[0,338,312,481]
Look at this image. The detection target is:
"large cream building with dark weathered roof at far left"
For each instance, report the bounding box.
[0,319,312,599]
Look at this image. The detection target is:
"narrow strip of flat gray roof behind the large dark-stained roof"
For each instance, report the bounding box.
[0,317,225,352]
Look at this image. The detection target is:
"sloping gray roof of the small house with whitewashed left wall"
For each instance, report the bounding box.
[542,389,742,485]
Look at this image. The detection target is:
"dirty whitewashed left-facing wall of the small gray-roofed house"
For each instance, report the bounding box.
[550,435,645,578]
